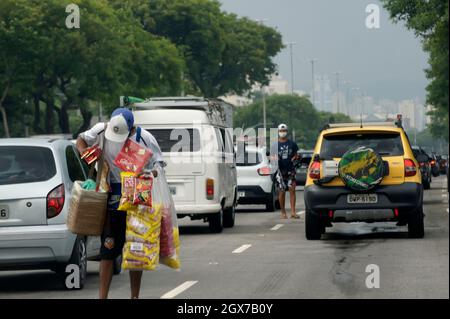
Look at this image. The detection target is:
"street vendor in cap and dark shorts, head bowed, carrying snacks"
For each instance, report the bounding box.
[77,108,163,299]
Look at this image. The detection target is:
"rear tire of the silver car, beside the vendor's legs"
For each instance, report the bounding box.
[56,237,87,290]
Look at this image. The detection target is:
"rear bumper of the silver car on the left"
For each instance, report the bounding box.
[0,225,76,269]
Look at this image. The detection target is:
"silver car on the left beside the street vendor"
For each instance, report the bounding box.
[0,138,120,288]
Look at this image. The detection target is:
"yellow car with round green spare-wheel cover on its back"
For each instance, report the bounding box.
[304,122,424,240]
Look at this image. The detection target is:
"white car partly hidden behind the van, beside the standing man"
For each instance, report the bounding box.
[236,146,279,212]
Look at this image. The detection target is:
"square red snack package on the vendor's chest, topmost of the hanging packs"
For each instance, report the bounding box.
[114,139,153,174]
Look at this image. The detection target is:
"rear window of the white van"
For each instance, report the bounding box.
[148,129,200,153]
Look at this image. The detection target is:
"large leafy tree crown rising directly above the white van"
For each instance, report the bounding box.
[121,0,283,97]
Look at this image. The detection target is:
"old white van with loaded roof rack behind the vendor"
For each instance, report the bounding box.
[129,97,237,233]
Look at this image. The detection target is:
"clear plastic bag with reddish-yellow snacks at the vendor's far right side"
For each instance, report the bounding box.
[152,167,181,269]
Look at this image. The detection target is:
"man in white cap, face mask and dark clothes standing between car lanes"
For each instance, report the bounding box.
[271,124,299,219]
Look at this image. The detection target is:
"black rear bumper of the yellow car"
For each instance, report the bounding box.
[304,183,423,220]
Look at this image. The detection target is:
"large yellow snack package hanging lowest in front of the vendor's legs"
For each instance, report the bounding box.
[122,205,161,270]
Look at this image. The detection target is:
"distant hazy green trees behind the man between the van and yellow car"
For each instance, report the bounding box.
[234,95,351,148]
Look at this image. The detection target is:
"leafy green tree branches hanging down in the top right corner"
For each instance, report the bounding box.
[383,0,449,141]
